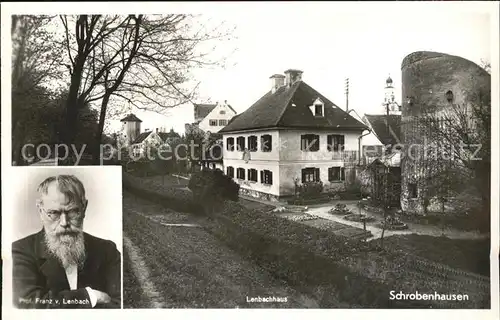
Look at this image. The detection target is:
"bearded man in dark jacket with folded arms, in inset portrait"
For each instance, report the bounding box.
[12,175,121,308]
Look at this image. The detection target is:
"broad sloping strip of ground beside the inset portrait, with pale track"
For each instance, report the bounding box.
[123,193,318,308]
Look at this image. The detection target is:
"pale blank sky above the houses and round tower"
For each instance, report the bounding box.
[48,3,491,133]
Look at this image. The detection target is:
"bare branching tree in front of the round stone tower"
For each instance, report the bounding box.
[420,84,491,227]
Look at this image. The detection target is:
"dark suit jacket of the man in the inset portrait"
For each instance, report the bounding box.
[12,230,121,308]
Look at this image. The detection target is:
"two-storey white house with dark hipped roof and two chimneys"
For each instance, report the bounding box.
[220,70,367,200]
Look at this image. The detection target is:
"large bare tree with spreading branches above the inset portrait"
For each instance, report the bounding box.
[61,14,235,162]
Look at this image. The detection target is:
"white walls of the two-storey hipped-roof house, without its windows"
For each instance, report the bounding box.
[223,130,361,196]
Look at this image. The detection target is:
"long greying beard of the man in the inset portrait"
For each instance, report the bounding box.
[45,232,87,269]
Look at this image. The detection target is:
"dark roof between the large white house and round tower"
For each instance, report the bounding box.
[365,114,401,145]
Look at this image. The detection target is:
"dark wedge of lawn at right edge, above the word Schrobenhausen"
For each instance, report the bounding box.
[374,234,490,276]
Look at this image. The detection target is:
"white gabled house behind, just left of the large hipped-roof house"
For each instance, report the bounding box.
[192,101,236,133]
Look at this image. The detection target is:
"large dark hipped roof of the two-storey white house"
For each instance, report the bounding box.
[220,81,366,132]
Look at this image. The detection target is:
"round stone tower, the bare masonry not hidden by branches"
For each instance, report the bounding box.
[401,51,491,213]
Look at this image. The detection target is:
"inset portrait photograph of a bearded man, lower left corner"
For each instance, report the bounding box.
[10,166,122,309]
